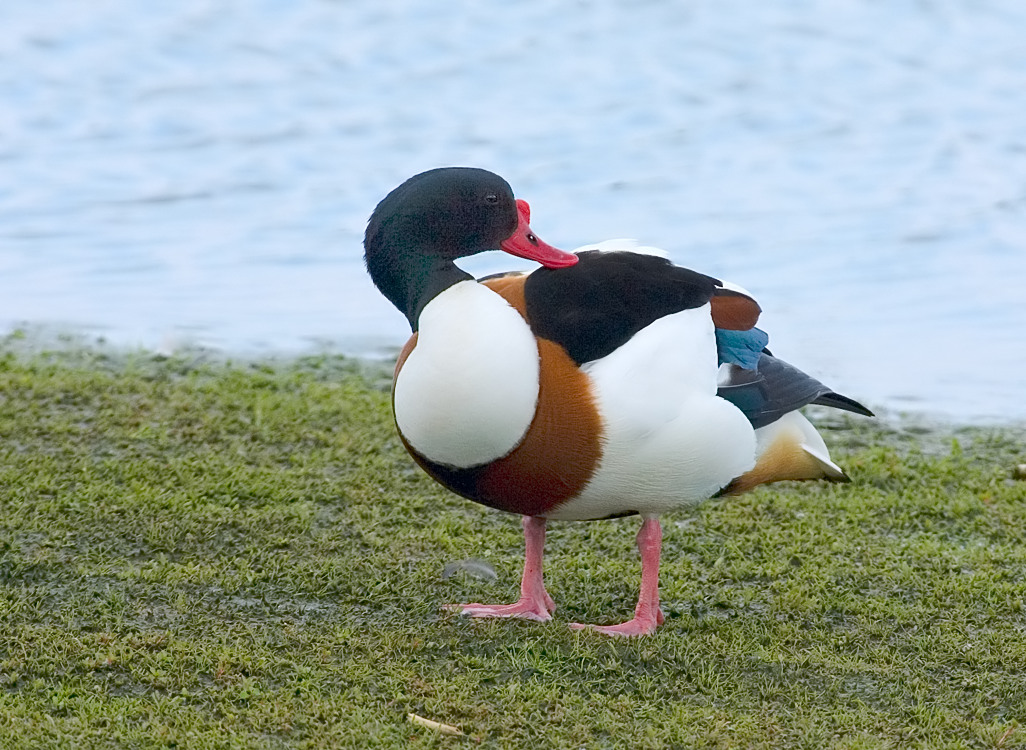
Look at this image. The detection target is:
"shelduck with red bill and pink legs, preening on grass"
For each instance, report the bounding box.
[364,167,871,635]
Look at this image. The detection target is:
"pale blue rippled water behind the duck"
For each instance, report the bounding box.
[0,0,1026,421]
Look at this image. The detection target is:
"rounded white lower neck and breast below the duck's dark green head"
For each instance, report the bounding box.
[394,281,539,468]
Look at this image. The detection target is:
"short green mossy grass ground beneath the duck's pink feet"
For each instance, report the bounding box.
[0,342,1026,749]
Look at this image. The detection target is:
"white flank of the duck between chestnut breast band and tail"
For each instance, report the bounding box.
[547,305,755,519]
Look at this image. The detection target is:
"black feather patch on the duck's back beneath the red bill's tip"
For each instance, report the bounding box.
[524,250,720,365]
